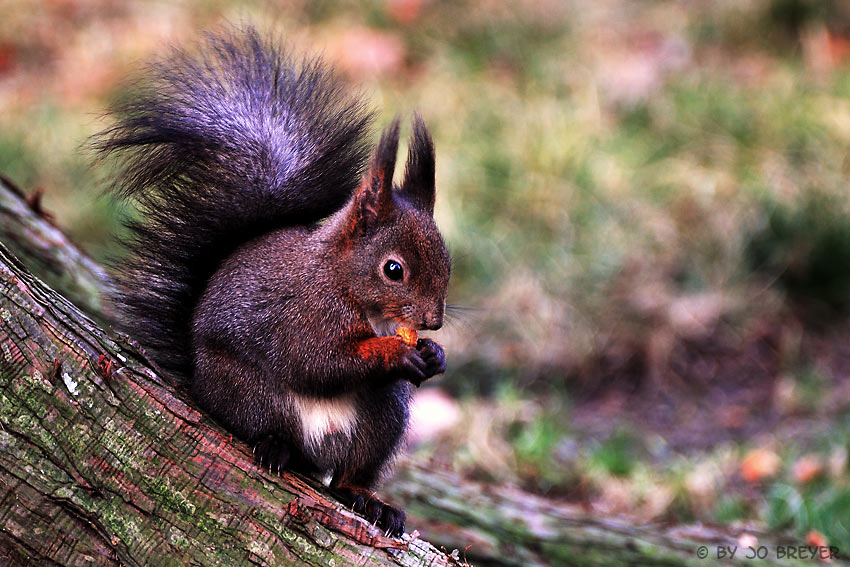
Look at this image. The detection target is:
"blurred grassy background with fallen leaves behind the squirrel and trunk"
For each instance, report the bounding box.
[0,0,850,550]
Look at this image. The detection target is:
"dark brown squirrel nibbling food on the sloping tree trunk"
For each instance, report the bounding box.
[95,27,451,536]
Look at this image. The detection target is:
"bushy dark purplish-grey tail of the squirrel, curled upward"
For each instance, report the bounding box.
[95,28,371,382]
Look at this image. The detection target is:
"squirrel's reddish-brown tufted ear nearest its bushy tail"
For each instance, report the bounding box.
[355,118,398,228]
